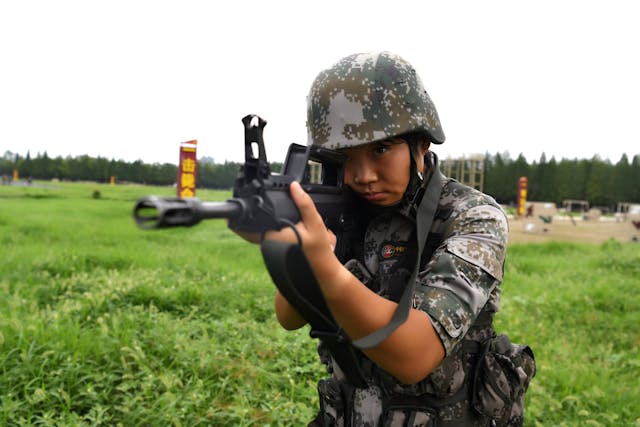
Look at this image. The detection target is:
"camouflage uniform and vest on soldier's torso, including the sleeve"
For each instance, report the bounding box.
[310,159,535,427]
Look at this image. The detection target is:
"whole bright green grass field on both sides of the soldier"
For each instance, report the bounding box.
[0,183,640,426]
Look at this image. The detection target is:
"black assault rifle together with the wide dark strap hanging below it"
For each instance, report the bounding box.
[133,115,366,387]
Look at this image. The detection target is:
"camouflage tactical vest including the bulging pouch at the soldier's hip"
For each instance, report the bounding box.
[310,180,535,427]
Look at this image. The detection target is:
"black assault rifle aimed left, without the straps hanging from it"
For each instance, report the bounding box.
[133,115,354,234]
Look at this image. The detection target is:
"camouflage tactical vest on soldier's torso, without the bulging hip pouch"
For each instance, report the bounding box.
[310,181,495,426]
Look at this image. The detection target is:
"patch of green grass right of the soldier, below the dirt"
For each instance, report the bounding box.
[497,240,640,426]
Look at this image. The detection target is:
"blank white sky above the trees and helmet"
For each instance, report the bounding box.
[0,0,640,164]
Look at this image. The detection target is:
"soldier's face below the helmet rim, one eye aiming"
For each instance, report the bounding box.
[343,138,411,206]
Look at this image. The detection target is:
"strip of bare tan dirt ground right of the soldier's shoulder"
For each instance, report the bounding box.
[509,217,640,243]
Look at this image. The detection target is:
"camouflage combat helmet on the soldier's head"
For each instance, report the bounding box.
[307,52,445,149]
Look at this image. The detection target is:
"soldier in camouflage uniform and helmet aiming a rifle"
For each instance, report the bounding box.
[252,52,534,426]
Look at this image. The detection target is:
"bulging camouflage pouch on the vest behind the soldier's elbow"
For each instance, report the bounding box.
[472,335,536,427]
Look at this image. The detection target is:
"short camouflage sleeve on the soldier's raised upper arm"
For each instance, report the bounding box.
[414,205,508,354]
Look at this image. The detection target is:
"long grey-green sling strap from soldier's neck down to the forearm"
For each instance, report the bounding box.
[353,163,446,349]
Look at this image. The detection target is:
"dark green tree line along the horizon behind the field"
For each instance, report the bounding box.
[0,152,640,209]
